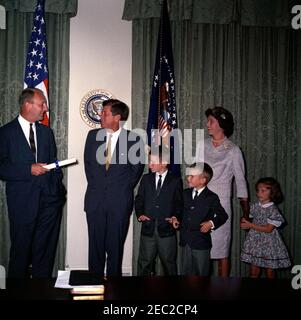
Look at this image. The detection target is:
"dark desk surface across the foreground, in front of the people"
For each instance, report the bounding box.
[0,276,301,303]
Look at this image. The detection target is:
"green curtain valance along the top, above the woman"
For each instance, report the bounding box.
[122,0,298,27]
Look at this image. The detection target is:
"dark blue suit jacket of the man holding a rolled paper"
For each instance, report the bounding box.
[0,118,63,218]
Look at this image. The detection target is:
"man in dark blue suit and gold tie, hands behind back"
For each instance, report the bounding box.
[84,99,145,275]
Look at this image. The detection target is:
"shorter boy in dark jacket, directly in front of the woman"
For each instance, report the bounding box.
[173,163,228,276]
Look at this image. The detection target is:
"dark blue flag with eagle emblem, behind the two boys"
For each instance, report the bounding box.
[147,0,180,175]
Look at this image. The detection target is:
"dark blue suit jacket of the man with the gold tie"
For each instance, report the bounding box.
[84,129,144,215]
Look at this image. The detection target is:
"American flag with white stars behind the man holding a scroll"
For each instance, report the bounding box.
[24,0,49,126]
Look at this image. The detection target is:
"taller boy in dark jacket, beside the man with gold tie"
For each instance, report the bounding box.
[135,148,183,276]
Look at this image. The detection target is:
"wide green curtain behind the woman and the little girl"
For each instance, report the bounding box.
[123,0,301,277]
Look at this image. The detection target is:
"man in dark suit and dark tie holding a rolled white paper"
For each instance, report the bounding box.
[0,88,64,278]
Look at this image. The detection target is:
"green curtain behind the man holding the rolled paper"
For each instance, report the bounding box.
[0,0,77,274]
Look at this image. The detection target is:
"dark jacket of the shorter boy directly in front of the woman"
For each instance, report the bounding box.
[180,187,228,250]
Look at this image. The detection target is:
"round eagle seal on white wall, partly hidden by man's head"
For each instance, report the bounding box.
[80,89,113,128]
